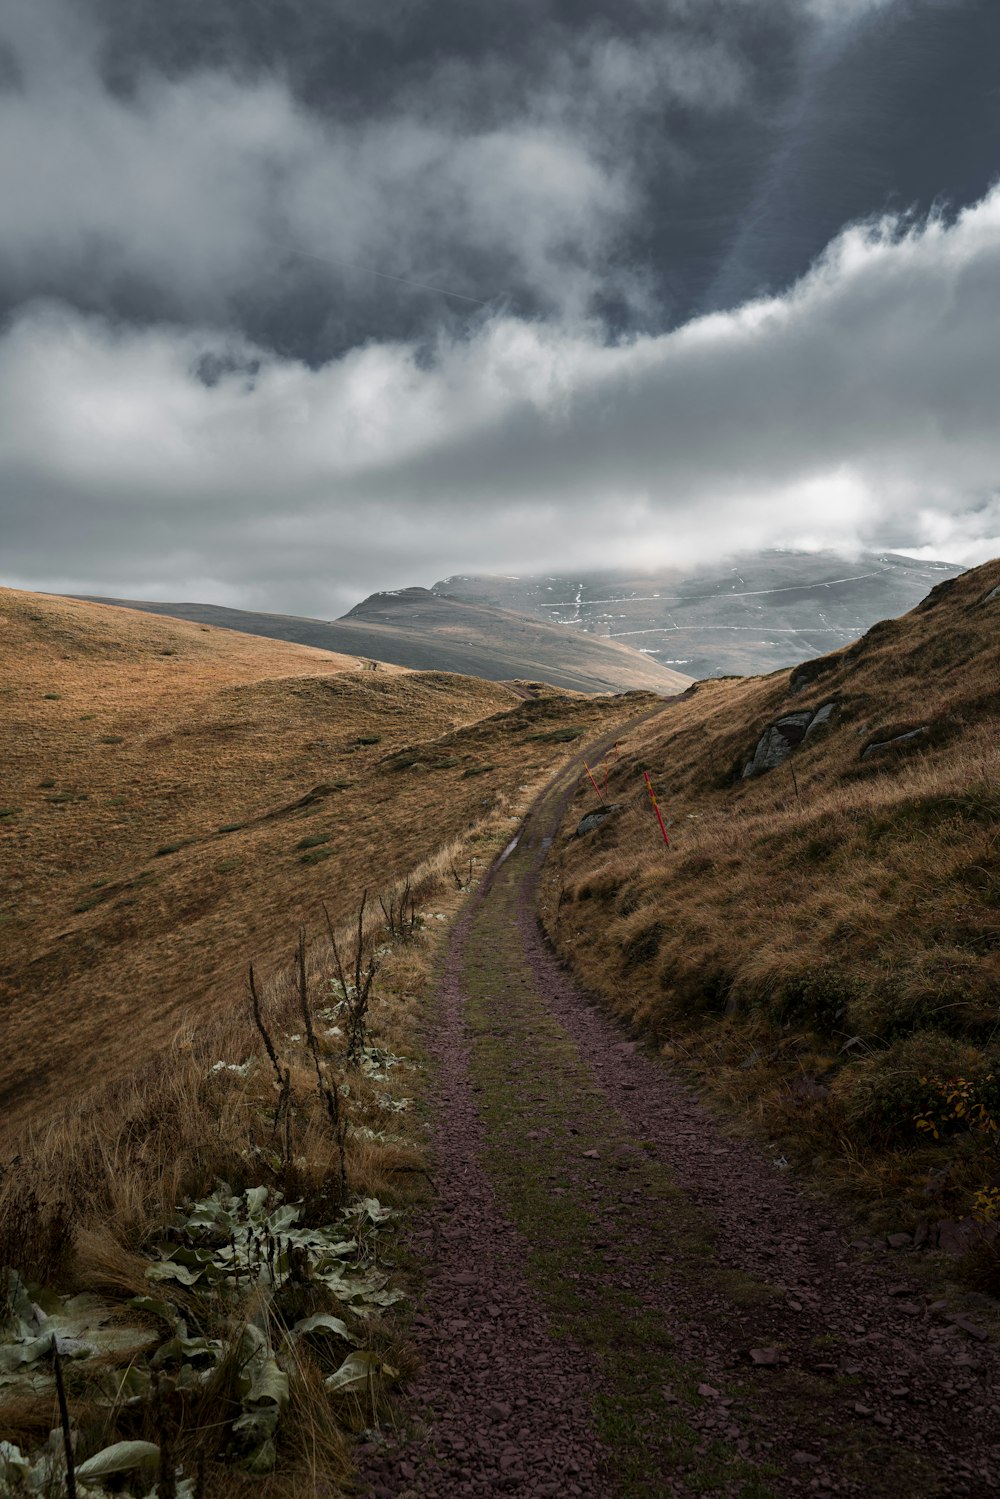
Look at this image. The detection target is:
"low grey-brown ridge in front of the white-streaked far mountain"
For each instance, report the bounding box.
[74,588,691,696]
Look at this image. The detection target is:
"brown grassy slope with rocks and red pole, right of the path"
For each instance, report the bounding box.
[546,561,1000,1259]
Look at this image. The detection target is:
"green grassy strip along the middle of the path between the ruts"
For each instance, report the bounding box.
[465,878,777,1499]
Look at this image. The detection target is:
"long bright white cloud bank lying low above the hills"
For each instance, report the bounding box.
[0,187,1000,612]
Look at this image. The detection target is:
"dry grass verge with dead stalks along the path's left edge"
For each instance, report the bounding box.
[0,793,554,1499]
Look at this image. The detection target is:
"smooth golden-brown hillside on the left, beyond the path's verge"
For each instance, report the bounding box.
[0,591,656,1130]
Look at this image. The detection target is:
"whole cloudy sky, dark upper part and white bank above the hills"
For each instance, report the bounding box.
[0,0,1000,615]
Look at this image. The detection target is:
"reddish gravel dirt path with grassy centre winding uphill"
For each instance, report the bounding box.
[366,743,1000,1499]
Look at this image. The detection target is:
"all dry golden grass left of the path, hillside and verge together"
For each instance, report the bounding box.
[0,594,668,1499]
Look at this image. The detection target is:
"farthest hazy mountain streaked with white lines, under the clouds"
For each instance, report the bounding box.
[432,550,963,678]
